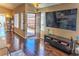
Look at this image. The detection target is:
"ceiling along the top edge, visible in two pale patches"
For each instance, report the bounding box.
[0,3,58,10]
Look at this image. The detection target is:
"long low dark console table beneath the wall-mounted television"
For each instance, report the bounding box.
[44,35,72,54]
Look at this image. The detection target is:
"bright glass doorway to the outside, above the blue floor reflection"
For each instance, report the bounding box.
[26,13,36,37]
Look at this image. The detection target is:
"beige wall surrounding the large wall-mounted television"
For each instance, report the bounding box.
[40,3,79,39]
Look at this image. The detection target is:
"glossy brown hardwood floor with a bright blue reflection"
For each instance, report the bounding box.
[7,32,67,56]
